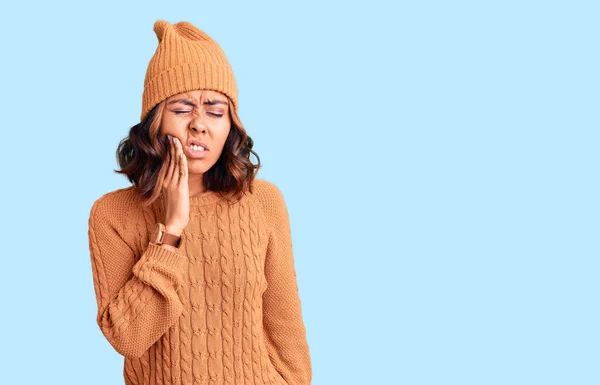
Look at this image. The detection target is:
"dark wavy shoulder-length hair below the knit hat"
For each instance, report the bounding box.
[113,98,260,206]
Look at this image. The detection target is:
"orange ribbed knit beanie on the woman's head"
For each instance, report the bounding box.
[140,20,238,120]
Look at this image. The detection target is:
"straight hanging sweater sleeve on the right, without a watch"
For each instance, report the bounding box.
[261,182,312,385]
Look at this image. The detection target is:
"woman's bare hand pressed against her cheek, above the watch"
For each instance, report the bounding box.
[163,135,190,235]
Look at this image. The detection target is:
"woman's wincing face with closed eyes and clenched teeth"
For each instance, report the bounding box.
[160,90,231,174]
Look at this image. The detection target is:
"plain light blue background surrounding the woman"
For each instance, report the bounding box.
[0,1,600,385]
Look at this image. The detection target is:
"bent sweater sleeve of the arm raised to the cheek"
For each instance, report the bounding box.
[88,198,187,358]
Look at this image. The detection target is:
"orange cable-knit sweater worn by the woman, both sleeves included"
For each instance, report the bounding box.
[88,179,312,385]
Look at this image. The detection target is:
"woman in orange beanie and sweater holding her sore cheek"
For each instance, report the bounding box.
[89,20,312,385]
